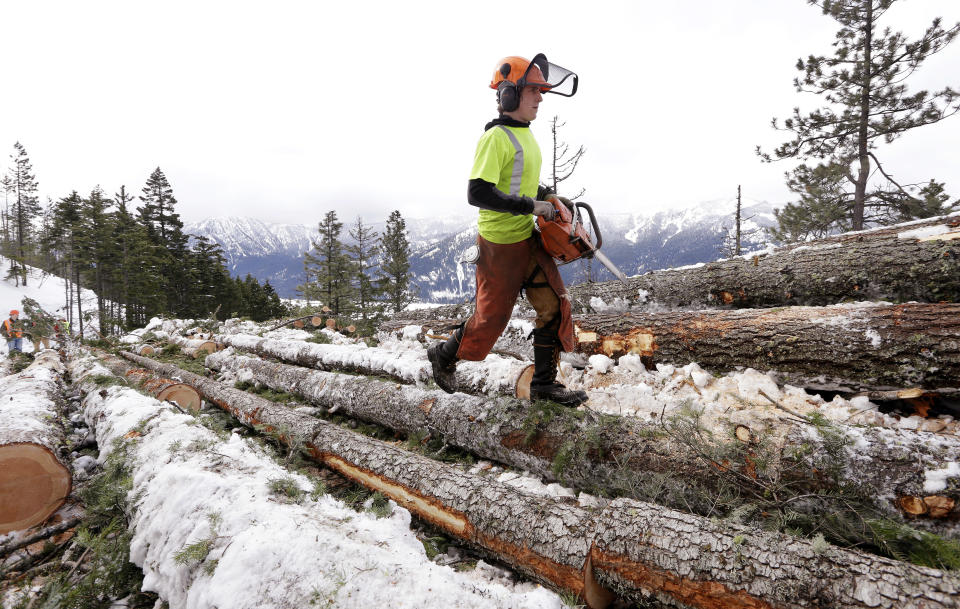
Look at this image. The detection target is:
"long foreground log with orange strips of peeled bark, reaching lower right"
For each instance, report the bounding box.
[116,353,960,609]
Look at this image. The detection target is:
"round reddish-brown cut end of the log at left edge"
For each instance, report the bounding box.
[0,443,71,534]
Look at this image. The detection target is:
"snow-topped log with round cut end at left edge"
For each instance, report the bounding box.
[0,350,72,534]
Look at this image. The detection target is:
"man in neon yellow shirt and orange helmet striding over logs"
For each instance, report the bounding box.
[427,53,587,406]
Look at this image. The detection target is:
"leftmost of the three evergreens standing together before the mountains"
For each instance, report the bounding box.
[297,211,353,316]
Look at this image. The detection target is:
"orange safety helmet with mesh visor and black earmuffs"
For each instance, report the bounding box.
[490,53,578,112]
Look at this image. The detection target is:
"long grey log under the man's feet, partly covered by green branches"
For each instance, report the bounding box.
[206,351,960,537]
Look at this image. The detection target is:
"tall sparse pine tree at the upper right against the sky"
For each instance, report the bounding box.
[757,0,960,237]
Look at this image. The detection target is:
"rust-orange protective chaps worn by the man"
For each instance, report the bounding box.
[457,233,574,361]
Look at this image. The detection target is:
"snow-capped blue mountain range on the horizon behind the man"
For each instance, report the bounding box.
[185,199,775,302]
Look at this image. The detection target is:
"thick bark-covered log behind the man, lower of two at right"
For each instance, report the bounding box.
[381,303,960,395]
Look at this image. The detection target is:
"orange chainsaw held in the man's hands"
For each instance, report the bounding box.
[537,195,627,283]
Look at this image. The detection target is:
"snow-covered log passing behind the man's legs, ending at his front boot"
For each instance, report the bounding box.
[217,334,531,397]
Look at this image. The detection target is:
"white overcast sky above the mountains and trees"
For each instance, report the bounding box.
[0,0,960,223]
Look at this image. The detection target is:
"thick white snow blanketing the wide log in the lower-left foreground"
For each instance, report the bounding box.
[71,357,563,609]
